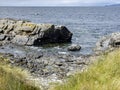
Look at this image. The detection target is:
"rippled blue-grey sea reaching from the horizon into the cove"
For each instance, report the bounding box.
[0,6,120,55]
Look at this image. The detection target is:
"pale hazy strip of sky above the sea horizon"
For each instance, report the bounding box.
[0,0,120,6]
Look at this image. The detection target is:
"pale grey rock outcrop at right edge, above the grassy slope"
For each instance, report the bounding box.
[95,32,120,51]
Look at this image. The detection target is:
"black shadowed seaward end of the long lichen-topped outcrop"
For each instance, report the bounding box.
[35,24,72,44]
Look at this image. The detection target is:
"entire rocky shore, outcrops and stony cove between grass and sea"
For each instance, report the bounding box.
[0,19,120,90]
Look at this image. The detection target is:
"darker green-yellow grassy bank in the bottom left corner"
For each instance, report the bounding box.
[0,56,39,90]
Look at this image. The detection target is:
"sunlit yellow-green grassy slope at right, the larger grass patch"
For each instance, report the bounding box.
[51,49,120,90]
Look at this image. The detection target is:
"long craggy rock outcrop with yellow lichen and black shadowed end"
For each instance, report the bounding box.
[0,19,72,46]
